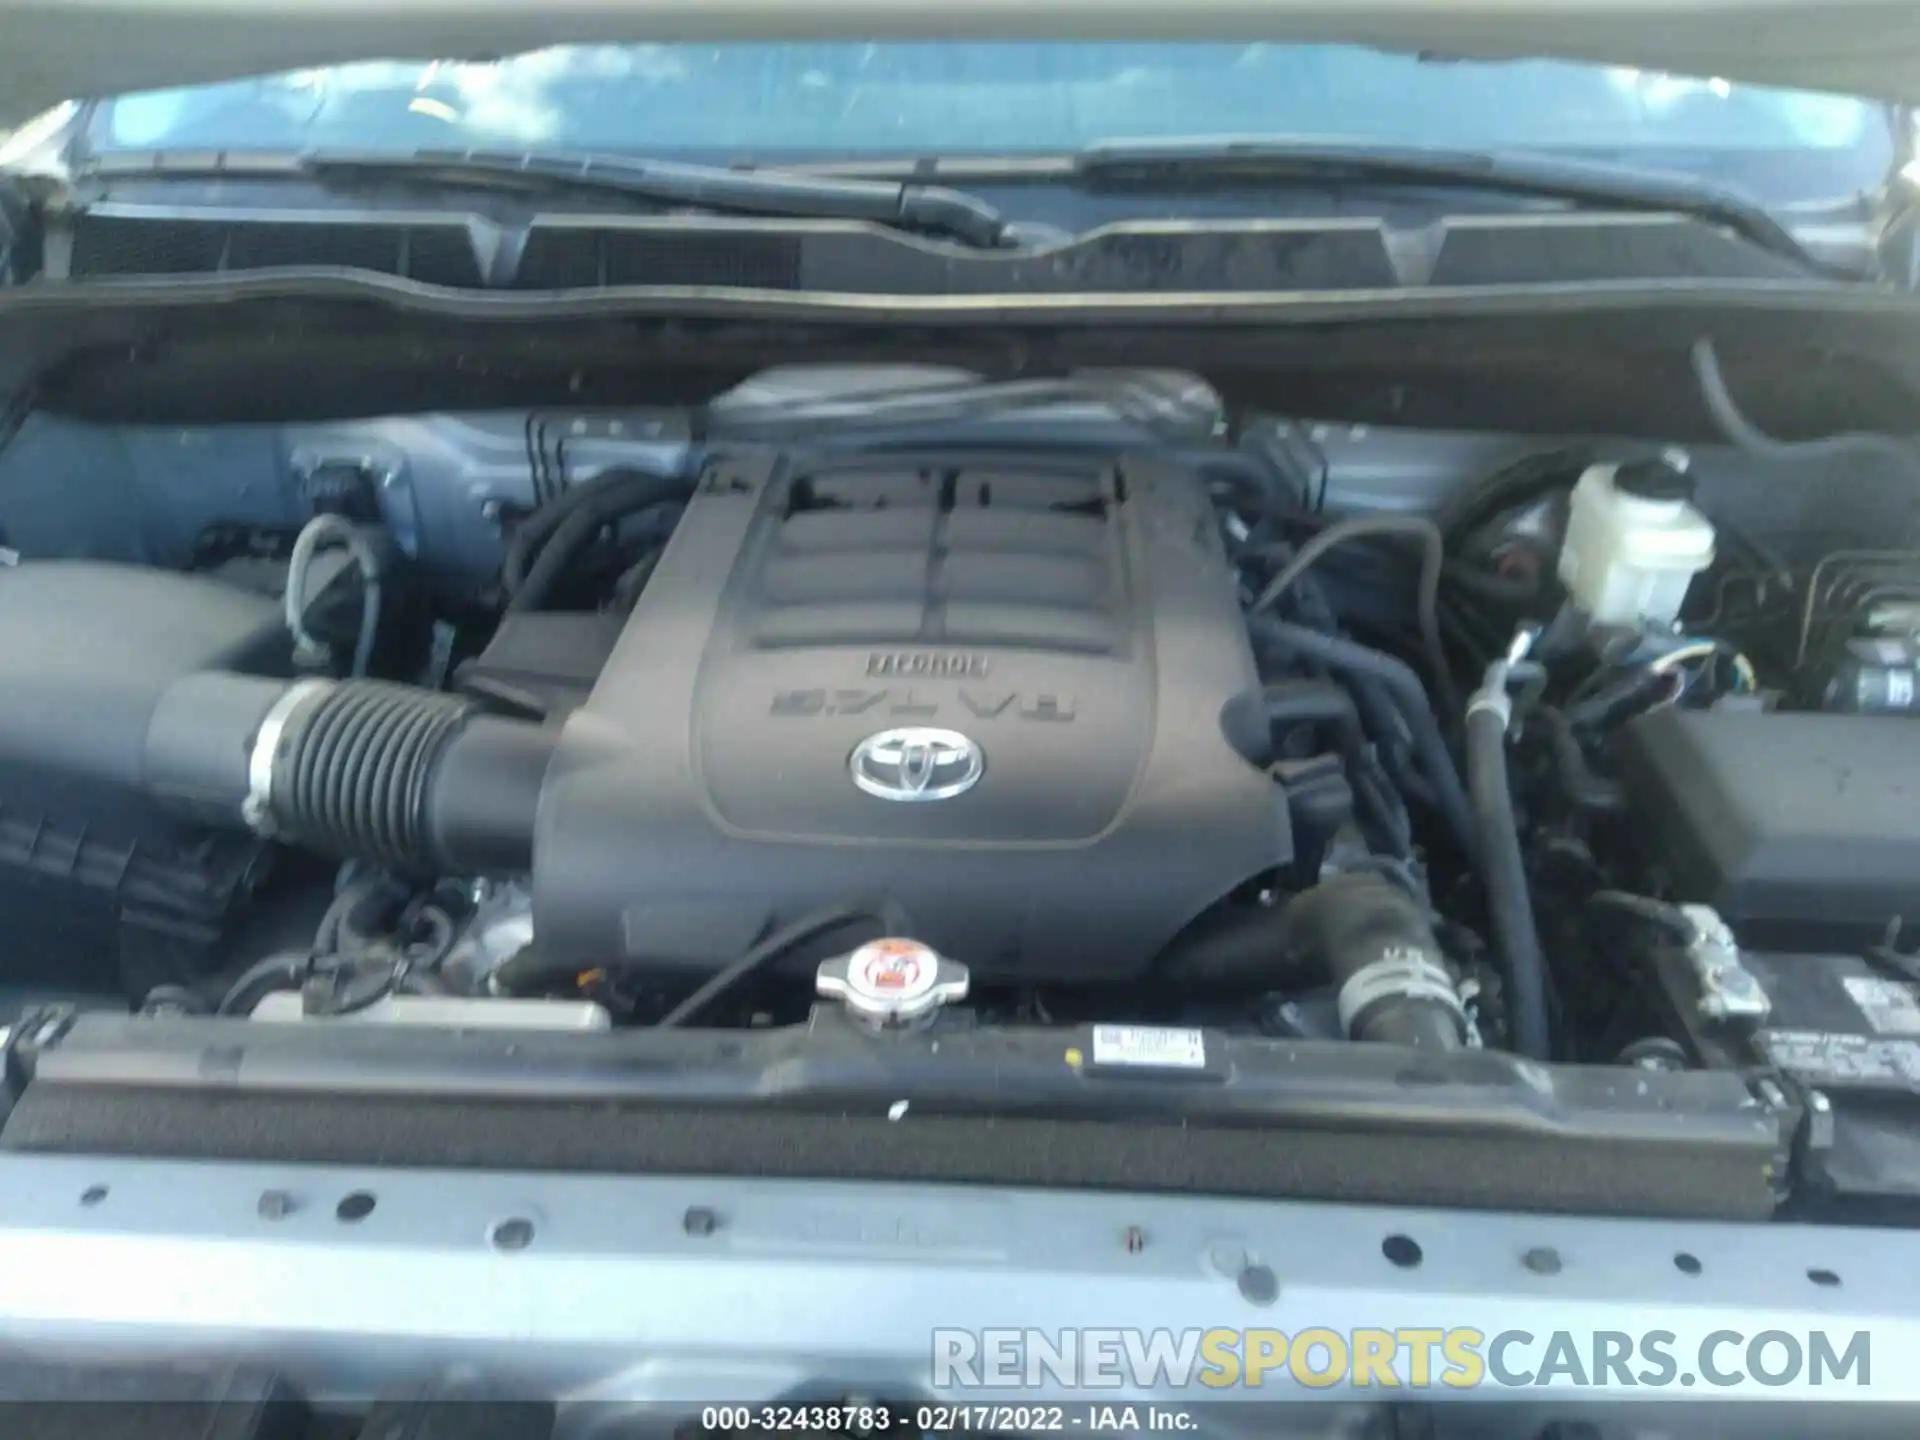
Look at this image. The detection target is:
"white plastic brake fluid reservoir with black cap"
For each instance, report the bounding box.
[1559,461,1713,626]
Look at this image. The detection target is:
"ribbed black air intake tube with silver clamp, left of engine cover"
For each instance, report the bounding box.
[146,674,557,874]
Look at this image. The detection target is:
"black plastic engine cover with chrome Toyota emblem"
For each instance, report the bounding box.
[534,455,1292,981]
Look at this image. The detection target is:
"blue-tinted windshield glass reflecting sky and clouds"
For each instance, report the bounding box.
[88,42,1895,198]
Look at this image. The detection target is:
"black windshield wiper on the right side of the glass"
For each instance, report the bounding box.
[1073,138,1872,280]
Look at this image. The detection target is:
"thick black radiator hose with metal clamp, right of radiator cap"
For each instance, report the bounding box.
[1156,874,1465,1050]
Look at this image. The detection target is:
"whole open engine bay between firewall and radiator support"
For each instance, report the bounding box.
[0,376,1920,1213]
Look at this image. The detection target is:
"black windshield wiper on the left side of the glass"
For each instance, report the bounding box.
[84,150,1008,248]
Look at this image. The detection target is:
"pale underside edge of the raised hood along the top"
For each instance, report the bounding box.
[0,0,1920,125]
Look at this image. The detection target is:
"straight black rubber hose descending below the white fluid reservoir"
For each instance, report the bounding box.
[1467,705,1549,1060]
